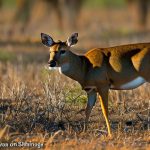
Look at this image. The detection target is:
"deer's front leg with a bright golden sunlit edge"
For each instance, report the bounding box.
[99,89,111,137]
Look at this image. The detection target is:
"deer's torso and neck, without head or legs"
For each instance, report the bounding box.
[60,43,150,90]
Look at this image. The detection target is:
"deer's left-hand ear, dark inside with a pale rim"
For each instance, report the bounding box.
[41,33,55,47]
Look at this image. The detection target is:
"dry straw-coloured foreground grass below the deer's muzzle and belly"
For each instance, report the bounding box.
[0,60,150,150]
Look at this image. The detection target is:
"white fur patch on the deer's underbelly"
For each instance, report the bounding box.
[111,77,146,90]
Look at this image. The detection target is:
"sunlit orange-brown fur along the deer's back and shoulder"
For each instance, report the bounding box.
[85,43,150,71]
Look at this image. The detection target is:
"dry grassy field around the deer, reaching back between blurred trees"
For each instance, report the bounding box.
[0,0,150,150]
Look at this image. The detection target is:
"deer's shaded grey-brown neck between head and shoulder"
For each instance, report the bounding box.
[60,52,86,84]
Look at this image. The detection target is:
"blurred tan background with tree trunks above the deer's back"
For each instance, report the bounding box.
[0,0,150,49]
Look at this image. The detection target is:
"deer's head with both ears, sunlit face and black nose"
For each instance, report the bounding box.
[41,33,78,67]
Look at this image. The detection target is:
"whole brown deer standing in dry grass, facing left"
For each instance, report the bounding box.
[41,33,150,136]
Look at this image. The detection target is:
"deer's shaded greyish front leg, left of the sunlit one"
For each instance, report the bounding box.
[84,89,96,131]
